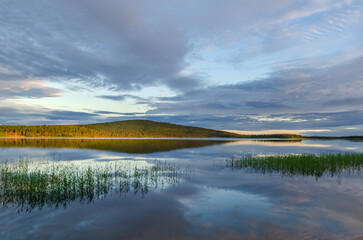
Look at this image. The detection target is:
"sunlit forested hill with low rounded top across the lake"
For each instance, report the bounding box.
[0,120,249,138]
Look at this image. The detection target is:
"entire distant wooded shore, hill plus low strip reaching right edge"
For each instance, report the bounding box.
[0,120,363,141]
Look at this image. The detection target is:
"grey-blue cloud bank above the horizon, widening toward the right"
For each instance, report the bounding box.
[0,47,363,134]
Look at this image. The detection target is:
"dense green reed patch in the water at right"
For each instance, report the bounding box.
[226,153,363,181]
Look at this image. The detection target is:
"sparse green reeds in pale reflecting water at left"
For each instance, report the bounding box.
[0,159,190,211]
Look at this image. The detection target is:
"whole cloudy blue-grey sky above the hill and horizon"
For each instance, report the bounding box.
[0,0,363,135]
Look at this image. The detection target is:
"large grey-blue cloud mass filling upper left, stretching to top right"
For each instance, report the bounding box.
[0,0,362,91]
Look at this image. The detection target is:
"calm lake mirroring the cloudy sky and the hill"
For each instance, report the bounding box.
[0,138,363,240]
